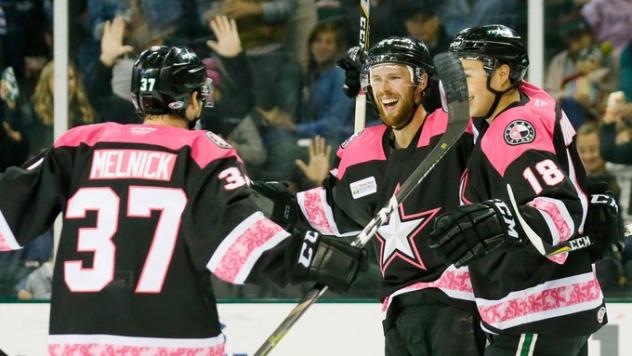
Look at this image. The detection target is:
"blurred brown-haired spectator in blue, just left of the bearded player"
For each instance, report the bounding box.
[268,22,354,146]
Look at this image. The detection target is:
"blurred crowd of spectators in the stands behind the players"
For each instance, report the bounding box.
[0,0,632,299]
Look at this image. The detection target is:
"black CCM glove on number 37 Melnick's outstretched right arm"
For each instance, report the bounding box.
[293,231,369,292]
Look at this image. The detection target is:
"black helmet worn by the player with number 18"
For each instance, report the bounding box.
[450,25,529,85]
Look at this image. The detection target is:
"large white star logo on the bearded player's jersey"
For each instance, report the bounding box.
[376,185,440,275]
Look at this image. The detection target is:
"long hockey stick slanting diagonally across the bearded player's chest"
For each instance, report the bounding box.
[255,52,469,356]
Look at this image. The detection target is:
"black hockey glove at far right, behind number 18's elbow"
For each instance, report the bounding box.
[584,183,623,262]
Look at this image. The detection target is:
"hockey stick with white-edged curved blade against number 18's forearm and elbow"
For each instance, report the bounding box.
[507,184,632,257]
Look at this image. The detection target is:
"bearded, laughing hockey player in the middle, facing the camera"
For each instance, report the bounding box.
[254,37,482,356]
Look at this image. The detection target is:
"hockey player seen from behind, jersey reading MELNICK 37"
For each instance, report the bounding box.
[0,46,363,356]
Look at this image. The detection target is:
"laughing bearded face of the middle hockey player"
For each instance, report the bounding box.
[369,63,425,127]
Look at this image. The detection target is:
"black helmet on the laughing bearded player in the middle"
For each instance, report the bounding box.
[366,37,434,82]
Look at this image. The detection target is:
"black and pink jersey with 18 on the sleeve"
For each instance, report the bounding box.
[462,82,606,336]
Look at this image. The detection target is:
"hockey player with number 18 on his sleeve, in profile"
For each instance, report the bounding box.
[431,25,607,356]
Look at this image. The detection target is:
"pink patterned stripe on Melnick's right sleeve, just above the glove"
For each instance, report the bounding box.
[213,218,284,283]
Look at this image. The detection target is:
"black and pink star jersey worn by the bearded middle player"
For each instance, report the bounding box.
[297,110,474,318]
